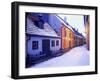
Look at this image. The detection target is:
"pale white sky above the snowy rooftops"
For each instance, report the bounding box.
[57,14,85,36]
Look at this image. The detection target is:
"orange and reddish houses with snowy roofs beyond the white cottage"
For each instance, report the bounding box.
[49,14,85,50]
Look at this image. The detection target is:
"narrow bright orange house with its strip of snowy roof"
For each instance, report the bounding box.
[54,16,74,50]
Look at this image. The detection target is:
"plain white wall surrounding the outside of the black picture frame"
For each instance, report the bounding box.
[0,0,100,81]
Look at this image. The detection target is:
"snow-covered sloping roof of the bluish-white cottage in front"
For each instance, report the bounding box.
[26,18,60,37]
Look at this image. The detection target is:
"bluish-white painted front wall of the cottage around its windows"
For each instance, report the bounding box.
[26,37,61,55]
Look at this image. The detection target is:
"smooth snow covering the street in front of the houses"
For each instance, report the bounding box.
[32,45,89,68]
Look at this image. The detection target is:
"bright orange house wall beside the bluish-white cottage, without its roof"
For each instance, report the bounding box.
[61,24,74,49]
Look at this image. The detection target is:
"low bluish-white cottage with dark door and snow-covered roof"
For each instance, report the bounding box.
[26,17,61,57]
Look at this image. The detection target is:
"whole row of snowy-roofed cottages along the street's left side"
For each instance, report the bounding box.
[25,13,85,66]
